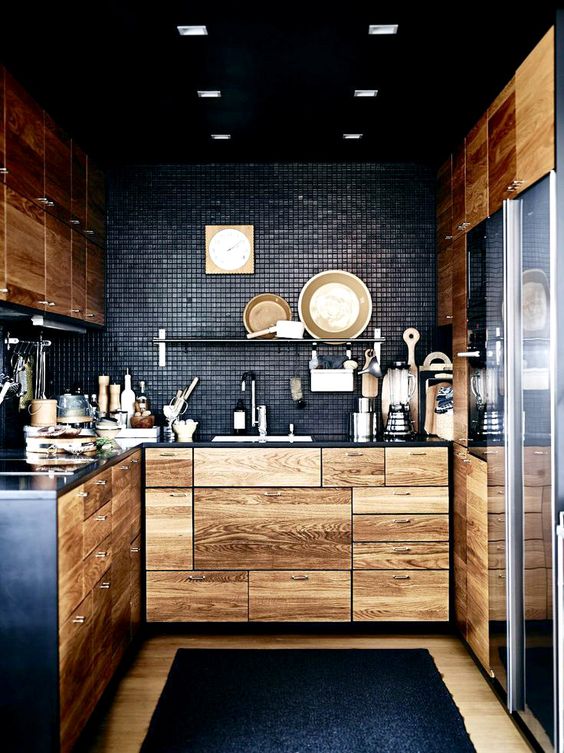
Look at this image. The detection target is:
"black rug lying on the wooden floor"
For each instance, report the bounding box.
[141,649,475,753]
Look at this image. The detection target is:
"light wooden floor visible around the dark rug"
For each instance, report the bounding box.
[81,634,530,753]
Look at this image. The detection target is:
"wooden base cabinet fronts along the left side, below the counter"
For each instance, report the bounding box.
[58,452,141,753]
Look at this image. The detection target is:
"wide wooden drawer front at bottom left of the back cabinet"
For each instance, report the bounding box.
[147,571,249,622]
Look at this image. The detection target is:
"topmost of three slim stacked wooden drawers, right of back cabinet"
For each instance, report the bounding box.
[353,486,449,514]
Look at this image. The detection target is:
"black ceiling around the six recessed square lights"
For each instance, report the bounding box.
[0,0,554,165]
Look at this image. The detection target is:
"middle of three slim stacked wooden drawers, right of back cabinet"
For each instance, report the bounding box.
[353,515,448,541]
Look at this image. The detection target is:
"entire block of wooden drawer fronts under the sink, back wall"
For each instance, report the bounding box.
[145,446,449,622]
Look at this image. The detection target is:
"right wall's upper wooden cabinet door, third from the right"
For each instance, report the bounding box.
[465,114,488,229]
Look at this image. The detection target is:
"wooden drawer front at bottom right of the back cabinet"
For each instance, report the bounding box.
[353,570,449,622]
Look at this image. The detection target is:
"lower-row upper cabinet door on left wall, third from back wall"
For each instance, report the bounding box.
[45,214,72,316]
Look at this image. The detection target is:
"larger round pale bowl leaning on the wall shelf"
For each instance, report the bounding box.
[298,269,372,342]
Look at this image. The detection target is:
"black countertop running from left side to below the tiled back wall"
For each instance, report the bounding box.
[0,435,451,499]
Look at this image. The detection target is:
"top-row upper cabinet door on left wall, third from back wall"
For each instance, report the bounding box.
[45,113,71,222]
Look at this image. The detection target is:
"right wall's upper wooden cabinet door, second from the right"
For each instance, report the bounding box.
[488,78,518,214]
